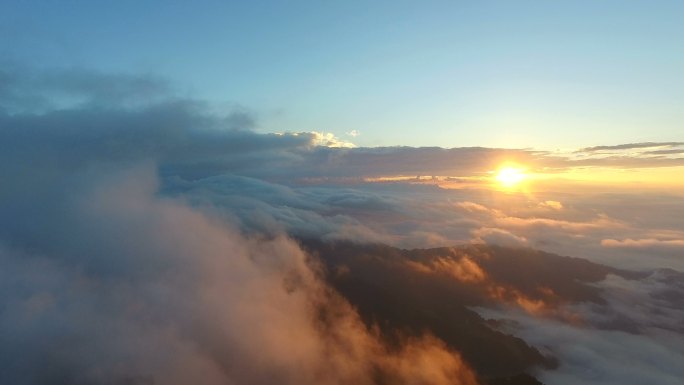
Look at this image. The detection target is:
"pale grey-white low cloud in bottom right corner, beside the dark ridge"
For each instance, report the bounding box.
[480,270,684,385]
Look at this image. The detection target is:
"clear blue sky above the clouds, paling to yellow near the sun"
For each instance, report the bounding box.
[0,0,684,149]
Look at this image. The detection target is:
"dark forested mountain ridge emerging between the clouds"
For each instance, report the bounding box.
[300,239,636,385]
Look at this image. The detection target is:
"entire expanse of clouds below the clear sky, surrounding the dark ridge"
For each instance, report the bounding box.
[0,64,684,384]
